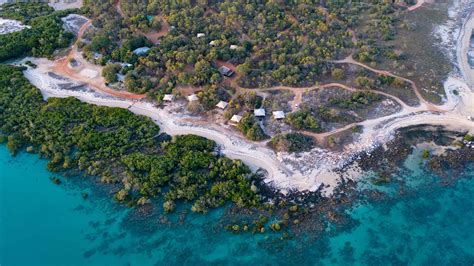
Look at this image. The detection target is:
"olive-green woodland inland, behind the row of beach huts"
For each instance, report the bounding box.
[80,0,409,95]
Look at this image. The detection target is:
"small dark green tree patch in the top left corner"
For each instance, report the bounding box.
[0,3,74,61]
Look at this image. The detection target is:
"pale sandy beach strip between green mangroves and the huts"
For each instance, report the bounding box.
[18,55,474,195]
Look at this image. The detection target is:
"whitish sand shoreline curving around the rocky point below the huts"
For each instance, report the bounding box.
[0,0,474,195]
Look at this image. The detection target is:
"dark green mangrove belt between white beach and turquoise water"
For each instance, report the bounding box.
[0,65,259,212]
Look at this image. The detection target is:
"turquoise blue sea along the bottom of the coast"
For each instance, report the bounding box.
[0,146,474,266]
